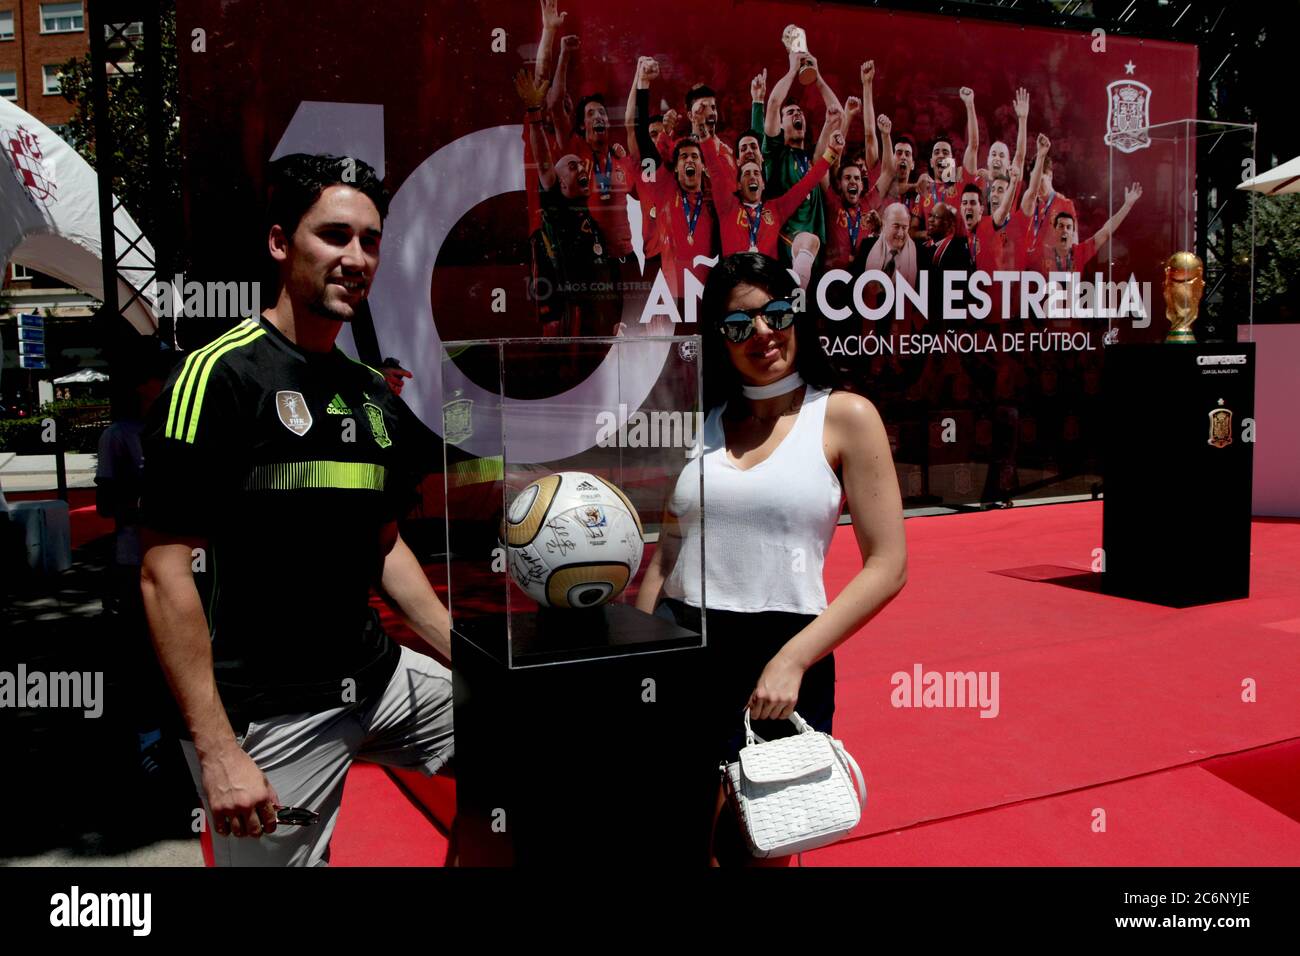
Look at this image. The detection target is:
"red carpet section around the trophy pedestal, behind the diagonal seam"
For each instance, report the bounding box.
[811,502,1300,848]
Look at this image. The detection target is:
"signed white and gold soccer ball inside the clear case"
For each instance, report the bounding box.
[502,471,645,607]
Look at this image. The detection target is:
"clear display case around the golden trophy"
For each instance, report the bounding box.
[1107,117,1255,343]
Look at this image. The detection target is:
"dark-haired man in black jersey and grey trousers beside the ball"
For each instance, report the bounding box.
[142,155,452,865]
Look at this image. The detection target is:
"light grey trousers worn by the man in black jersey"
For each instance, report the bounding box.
[182,648,454,866]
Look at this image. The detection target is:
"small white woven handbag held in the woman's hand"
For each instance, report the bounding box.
[723,708,867,857]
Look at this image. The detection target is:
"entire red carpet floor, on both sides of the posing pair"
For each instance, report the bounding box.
[263,502,1300,866]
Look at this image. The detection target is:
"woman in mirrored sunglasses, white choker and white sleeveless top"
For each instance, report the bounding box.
[637,252,907,863]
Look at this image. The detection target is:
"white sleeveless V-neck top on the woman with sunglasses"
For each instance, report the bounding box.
[663,385,842,614]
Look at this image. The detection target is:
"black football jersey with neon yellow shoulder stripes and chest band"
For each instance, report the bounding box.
[143,319,441,732]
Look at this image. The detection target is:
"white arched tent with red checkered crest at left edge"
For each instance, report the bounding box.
[0,99,157,334]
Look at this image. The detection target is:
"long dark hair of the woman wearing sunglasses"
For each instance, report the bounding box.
[699,252,848,411]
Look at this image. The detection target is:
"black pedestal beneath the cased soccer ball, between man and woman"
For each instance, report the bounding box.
[451,605,719,866]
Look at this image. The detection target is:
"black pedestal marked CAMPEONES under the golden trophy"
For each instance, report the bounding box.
[1101,343,1255,607]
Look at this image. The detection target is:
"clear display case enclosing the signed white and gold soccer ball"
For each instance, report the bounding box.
[441,336,706,670]
